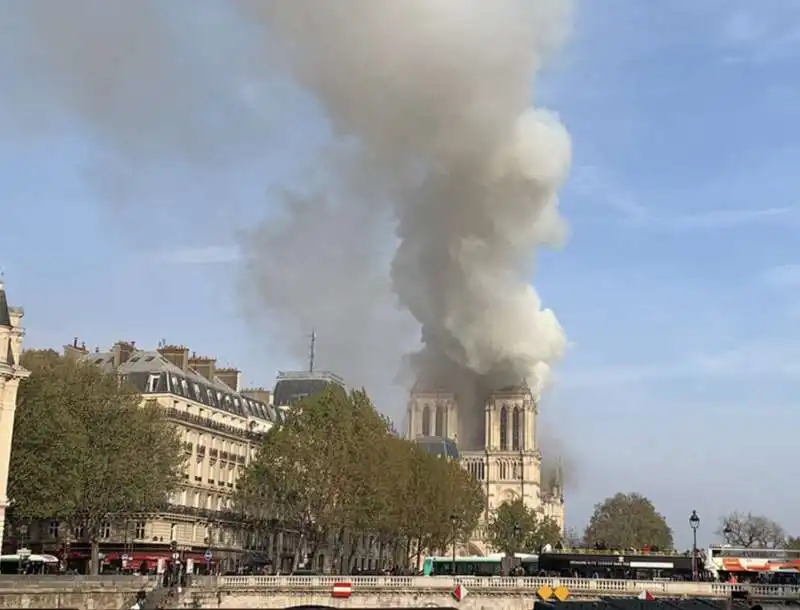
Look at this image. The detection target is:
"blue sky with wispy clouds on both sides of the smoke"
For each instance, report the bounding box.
[0,0,800,546]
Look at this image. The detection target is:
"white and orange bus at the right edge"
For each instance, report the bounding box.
[705,546,800,584]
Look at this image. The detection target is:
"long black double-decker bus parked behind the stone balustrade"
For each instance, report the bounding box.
[539,549,704,580]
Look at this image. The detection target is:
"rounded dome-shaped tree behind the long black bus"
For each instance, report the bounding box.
[584,493,673,551]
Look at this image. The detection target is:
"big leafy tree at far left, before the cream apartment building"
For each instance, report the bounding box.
[9,350,185,573]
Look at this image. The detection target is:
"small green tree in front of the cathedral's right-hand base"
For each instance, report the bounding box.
[488,499,561,555]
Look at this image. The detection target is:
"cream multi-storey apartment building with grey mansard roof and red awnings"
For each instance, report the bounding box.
[13,339,284,571]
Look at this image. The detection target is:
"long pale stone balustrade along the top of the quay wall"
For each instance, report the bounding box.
[200,576,800,598]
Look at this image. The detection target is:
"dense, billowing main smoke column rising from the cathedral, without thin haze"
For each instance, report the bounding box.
[241,0,570,444]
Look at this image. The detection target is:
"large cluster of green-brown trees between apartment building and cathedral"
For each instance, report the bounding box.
[235,388,483,563]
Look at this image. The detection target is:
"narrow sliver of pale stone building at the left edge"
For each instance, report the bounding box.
[0,277,29,549]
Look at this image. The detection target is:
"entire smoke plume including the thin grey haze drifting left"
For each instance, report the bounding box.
[0,0,571,445]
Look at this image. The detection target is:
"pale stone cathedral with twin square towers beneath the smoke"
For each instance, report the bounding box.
[408,383,564,555]
